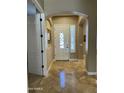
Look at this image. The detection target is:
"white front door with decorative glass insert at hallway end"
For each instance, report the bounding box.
[54,24,69,60]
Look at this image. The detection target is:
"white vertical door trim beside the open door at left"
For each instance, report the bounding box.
[32,0,48,76]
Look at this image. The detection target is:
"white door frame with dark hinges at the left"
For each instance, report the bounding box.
[31,0,47,76]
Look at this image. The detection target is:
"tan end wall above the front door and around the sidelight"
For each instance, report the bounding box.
[52,16,78,59]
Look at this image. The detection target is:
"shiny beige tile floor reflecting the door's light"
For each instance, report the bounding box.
[28,60,97,93]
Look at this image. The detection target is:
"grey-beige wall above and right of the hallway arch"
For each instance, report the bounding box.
[44,0,97,72]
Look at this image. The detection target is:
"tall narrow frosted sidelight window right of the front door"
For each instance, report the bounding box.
[70,25,76,53]
